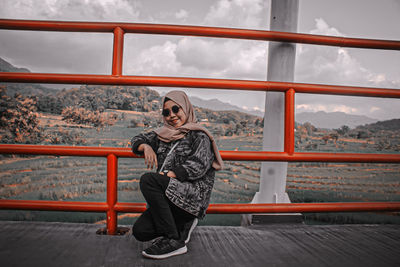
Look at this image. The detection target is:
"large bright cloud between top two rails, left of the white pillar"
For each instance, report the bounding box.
[127,37,267,79]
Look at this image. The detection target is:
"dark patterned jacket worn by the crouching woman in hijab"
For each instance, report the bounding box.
[131,131,215,218]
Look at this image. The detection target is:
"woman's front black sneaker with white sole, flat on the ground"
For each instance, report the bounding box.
[142,237,187,260]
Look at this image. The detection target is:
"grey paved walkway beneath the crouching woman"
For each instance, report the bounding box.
[0,221,400,267]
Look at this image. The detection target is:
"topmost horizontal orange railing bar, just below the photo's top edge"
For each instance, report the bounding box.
[0,19,400,50]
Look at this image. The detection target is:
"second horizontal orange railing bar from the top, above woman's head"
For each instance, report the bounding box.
[0,72,400,98]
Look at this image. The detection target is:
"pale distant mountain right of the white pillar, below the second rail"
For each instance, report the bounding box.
[296,111,378,129]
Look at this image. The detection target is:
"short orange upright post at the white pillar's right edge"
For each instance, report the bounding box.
[285,88,295,155]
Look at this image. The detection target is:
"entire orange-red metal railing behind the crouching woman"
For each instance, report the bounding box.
[0,19,400,234]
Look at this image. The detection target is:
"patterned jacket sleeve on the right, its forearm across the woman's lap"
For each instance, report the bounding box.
[172,132,214,182]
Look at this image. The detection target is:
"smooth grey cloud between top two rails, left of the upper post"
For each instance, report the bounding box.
[0,31,112,74]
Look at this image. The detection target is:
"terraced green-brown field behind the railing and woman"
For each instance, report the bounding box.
[0,111,400,225]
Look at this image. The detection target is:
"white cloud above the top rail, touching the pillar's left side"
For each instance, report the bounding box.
[204,0,269,28]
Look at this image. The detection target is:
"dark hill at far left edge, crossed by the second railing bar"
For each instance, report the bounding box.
[0,58,58,96]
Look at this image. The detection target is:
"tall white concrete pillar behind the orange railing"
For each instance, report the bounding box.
[252,0,299,206]
